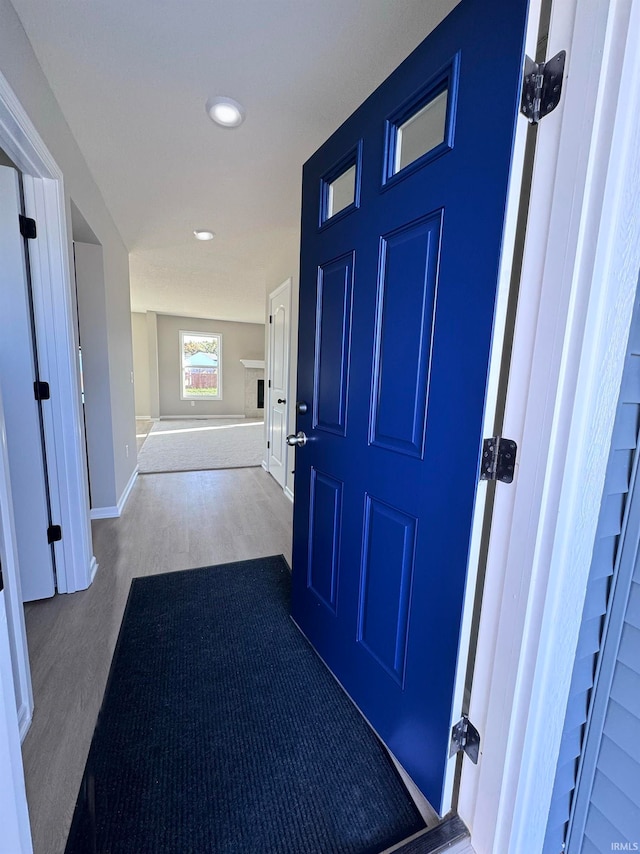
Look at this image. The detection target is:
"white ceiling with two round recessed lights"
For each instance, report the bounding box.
[12,0,458,322]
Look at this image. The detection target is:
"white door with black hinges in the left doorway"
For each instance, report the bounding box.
[0,166,55,602]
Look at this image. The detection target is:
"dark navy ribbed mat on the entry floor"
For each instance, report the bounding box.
[66,556,424,854]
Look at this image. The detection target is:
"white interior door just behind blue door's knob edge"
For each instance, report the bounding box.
[267,279,291,489]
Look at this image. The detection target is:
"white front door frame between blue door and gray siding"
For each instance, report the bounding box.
[458,0,640,854]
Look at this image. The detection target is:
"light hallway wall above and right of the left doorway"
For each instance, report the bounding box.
[0,0,135,504]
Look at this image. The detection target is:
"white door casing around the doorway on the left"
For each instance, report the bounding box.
[0,61,97,854]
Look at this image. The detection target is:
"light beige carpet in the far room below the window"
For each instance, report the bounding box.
[138,418,264,474]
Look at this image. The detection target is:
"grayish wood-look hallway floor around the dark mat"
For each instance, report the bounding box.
[23,468,292,854]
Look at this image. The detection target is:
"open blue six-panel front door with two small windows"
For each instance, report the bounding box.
[292,0,527,809]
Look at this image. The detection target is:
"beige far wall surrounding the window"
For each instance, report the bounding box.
[157,314,264,418]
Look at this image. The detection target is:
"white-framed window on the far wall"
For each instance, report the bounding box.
[180,331,222,400]
